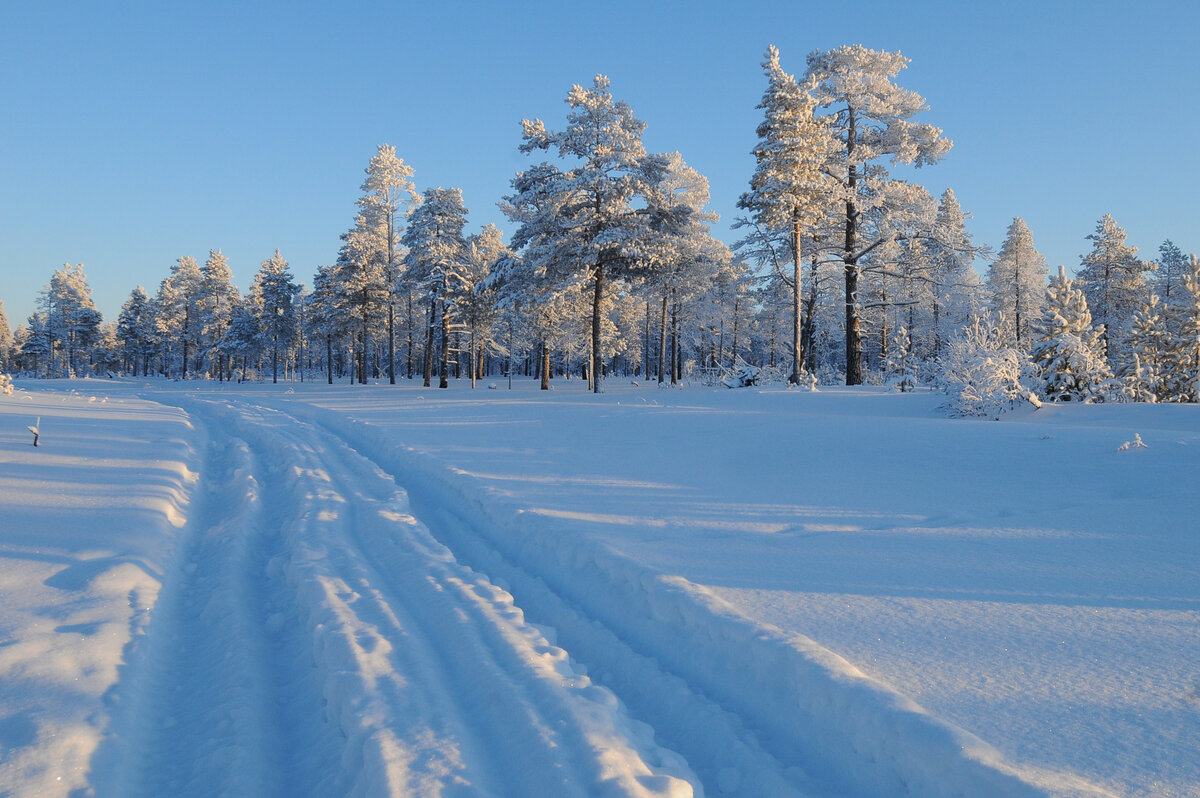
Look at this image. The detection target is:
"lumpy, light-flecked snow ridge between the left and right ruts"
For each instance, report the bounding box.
[182,398,692,796]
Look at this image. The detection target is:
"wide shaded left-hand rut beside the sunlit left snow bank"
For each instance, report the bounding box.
[94,427,312,798]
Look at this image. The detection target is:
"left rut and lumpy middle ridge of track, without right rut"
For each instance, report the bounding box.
[95,401,702,797]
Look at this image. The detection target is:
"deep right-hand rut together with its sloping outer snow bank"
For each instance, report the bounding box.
[265,402,1109,798]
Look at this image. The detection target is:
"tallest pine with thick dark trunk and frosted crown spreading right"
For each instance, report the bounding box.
[805,44,952,385]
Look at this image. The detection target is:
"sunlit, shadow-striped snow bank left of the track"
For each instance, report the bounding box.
[0,383,197,797]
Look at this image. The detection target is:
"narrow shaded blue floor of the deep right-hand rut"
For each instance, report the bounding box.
[244,403,825,798]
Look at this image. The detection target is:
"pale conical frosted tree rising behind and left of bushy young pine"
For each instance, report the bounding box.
[986,216,1048,352]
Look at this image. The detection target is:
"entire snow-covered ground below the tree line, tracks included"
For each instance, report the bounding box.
[0,380,1200,797]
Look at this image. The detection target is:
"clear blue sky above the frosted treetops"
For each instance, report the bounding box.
[0,0,1200,328]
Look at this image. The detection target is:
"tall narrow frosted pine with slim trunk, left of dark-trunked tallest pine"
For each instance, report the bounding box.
[738,44,834,384]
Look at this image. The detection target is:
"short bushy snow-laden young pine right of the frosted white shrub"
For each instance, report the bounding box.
[1033,266,1112,402]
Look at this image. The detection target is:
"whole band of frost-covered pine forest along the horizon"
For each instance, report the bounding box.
[0,46,1200,415]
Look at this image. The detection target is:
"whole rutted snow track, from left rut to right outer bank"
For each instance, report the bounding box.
[87,397,1113,798]
